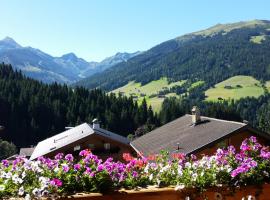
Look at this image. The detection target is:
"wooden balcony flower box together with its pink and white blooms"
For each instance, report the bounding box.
[0,137,270,200]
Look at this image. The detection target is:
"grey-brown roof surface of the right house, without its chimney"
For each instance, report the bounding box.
[131,115,248,155]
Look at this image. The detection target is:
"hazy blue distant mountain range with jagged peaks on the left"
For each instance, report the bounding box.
[0,37,138,84]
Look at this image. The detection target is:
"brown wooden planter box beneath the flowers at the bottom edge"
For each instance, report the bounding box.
[57,184,270,200]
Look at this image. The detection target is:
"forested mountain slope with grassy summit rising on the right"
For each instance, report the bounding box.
[77,20,270,91]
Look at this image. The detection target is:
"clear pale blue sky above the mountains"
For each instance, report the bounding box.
[0,0,270,61]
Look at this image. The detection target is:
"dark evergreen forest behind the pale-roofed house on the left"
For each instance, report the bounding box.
[0,64,158,147]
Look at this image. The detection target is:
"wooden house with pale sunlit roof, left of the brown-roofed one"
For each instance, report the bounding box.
[30,120,134,160]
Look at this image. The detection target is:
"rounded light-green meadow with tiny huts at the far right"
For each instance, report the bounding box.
[205,76,270,101]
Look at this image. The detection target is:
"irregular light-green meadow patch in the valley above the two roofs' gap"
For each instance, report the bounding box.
[112,78,185,112]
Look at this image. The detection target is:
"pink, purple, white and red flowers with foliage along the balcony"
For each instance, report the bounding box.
[0,137,270,199]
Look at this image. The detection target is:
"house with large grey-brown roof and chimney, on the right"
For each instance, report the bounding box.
[131,107,270,155]
